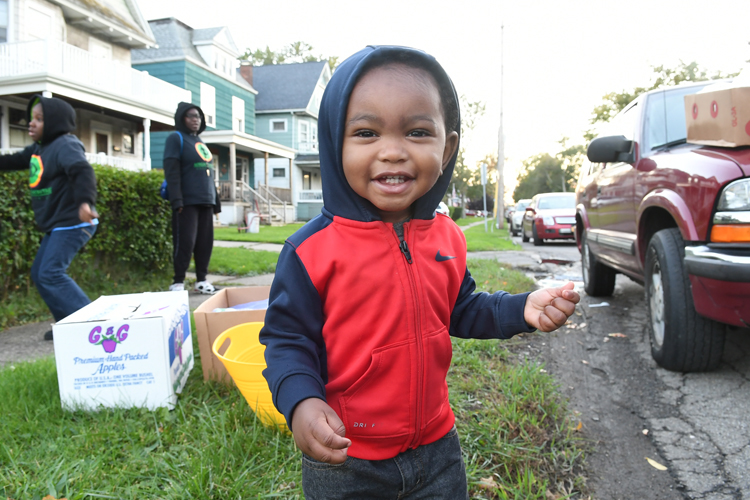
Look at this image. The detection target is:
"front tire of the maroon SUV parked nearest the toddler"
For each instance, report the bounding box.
[645,228,726,372]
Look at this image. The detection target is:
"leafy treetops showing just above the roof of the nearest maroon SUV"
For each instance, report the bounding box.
[587,61,739,124]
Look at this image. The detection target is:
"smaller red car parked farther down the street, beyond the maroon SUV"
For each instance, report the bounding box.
[521,193,576,246]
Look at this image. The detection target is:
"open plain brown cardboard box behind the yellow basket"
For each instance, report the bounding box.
[193,286,271,383]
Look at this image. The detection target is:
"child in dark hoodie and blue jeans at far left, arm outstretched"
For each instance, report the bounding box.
[0,95,99,340]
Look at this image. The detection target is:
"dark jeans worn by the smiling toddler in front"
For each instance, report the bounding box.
[302,427,469,500]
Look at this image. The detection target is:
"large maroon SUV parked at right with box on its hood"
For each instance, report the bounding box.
[576,82,750,371]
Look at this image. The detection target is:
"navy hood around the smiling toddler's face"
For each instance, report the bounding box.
[318,46,461,222]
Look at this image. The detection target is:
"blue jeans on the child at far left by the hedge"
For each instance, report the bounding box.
[31,226,96,321]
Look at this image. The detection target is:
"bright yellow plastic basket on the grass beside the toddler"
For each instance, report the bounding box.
[212,323,287,430]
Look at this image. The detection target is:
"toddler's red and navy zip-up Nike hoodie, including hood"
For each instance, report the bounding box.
[260,47,533,460]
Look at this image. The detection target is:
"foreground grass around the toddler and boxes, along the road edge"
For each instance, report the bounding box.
[0,260,583,500]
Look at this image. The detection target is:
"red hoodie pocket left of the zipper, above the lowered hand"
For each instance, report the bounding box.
[340,341,416,438]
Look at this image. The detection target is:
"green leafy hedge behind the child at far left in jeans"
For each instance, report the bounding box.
[0,165,172,300]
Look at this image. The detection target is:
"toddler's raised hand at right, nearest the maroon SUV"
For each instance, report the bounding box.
[523,281,581,332]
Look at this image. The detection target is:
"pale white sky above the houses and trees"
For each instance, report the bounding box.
[138,0,750,191]
